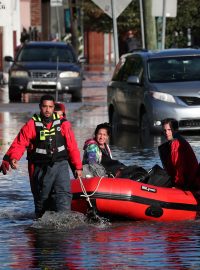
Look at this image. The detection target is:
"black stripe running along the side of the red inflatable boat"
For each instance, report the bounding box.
[73,192,200,211]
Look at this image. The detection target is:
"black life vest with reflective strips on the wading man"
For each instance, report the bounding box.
[28,114,68,164]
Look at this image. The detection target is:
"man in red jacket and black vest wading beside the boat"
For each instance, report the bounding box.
[0,95,82,217]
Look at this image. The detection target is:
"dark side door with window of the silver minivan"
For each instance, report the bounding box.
[118,55,143,125]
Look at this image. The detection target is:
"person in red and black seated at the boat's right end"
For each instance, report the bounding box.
[158,118,200,191]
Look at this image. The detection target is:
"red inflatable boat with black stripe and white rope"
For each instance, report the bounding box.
[71,177,200,221]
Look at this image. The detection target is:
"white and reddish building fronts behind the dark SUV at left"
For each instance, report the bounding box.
[0,0,113,76]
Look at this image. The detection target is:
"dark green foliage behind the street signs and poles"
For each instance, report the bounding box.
[83,0,200,48]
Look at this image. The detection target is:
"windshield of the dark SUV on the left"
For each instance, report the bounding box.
[17,46,76,63]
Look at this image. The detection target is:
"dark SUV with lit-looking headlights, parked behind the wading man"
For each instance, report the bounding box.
[5,41,83,101]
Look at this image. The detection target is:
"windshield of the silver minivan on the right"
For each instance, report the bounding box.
[147,56,200,82]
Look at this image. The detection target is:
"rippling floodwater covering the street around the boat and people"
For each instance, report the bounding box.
[0,70,200,270]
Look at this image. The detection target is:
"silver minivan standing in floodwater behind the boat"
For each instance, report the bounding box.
[107,48,200,132]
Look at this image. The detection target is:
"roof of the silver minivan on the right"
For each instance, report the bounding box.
[122,48,200,59]
